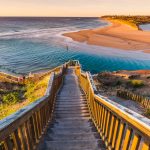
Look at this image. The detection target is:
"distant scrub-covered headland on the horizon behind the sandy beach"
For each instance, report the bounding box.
[102,15,150,28]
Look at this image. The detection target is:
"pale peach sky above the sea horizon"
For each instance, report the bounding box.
[0,0,150,17]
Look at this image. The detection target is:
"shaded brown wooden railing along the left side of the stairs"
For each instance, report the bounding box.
[0,65,66,150]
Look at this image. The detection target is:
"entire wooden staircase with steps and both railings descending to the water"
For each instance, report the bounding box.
[0,60,150,150]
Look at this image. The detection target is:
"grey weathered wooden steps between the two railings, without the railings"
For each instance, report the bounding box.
[39,68,106,150]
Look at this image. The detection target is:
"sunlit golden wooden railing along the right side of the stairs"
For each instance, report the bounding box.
[76,67,150,150]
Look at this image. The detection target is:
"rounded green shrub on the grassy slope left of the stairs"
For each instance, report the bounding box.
[2,92,20,104]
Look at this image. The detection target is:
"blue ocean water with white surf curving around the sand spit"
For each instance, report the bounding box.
[0,18,150,74]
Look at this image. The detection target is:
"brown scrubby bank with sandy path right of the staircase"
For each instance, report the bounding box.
[94,71,150,118]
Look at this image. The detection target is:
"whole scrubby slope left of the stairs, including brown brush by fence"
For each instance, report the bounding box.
[0,74,50,119]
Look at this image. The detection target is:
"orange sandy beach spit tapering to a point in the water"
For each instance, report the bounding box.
[63,20,150,53]
